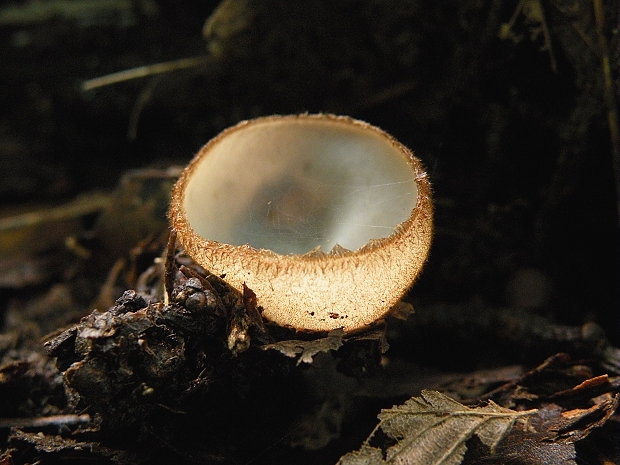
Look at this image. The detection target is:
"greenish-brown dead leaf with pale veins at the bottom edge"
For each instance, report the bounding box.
[338,390,535,465]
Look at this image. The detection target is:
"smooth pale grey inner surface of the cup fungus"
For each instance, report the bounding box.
[184,119,417,254]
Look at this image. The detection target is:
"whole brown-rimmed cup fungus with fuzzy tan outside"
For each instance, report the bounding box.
[170,114,433,331]
